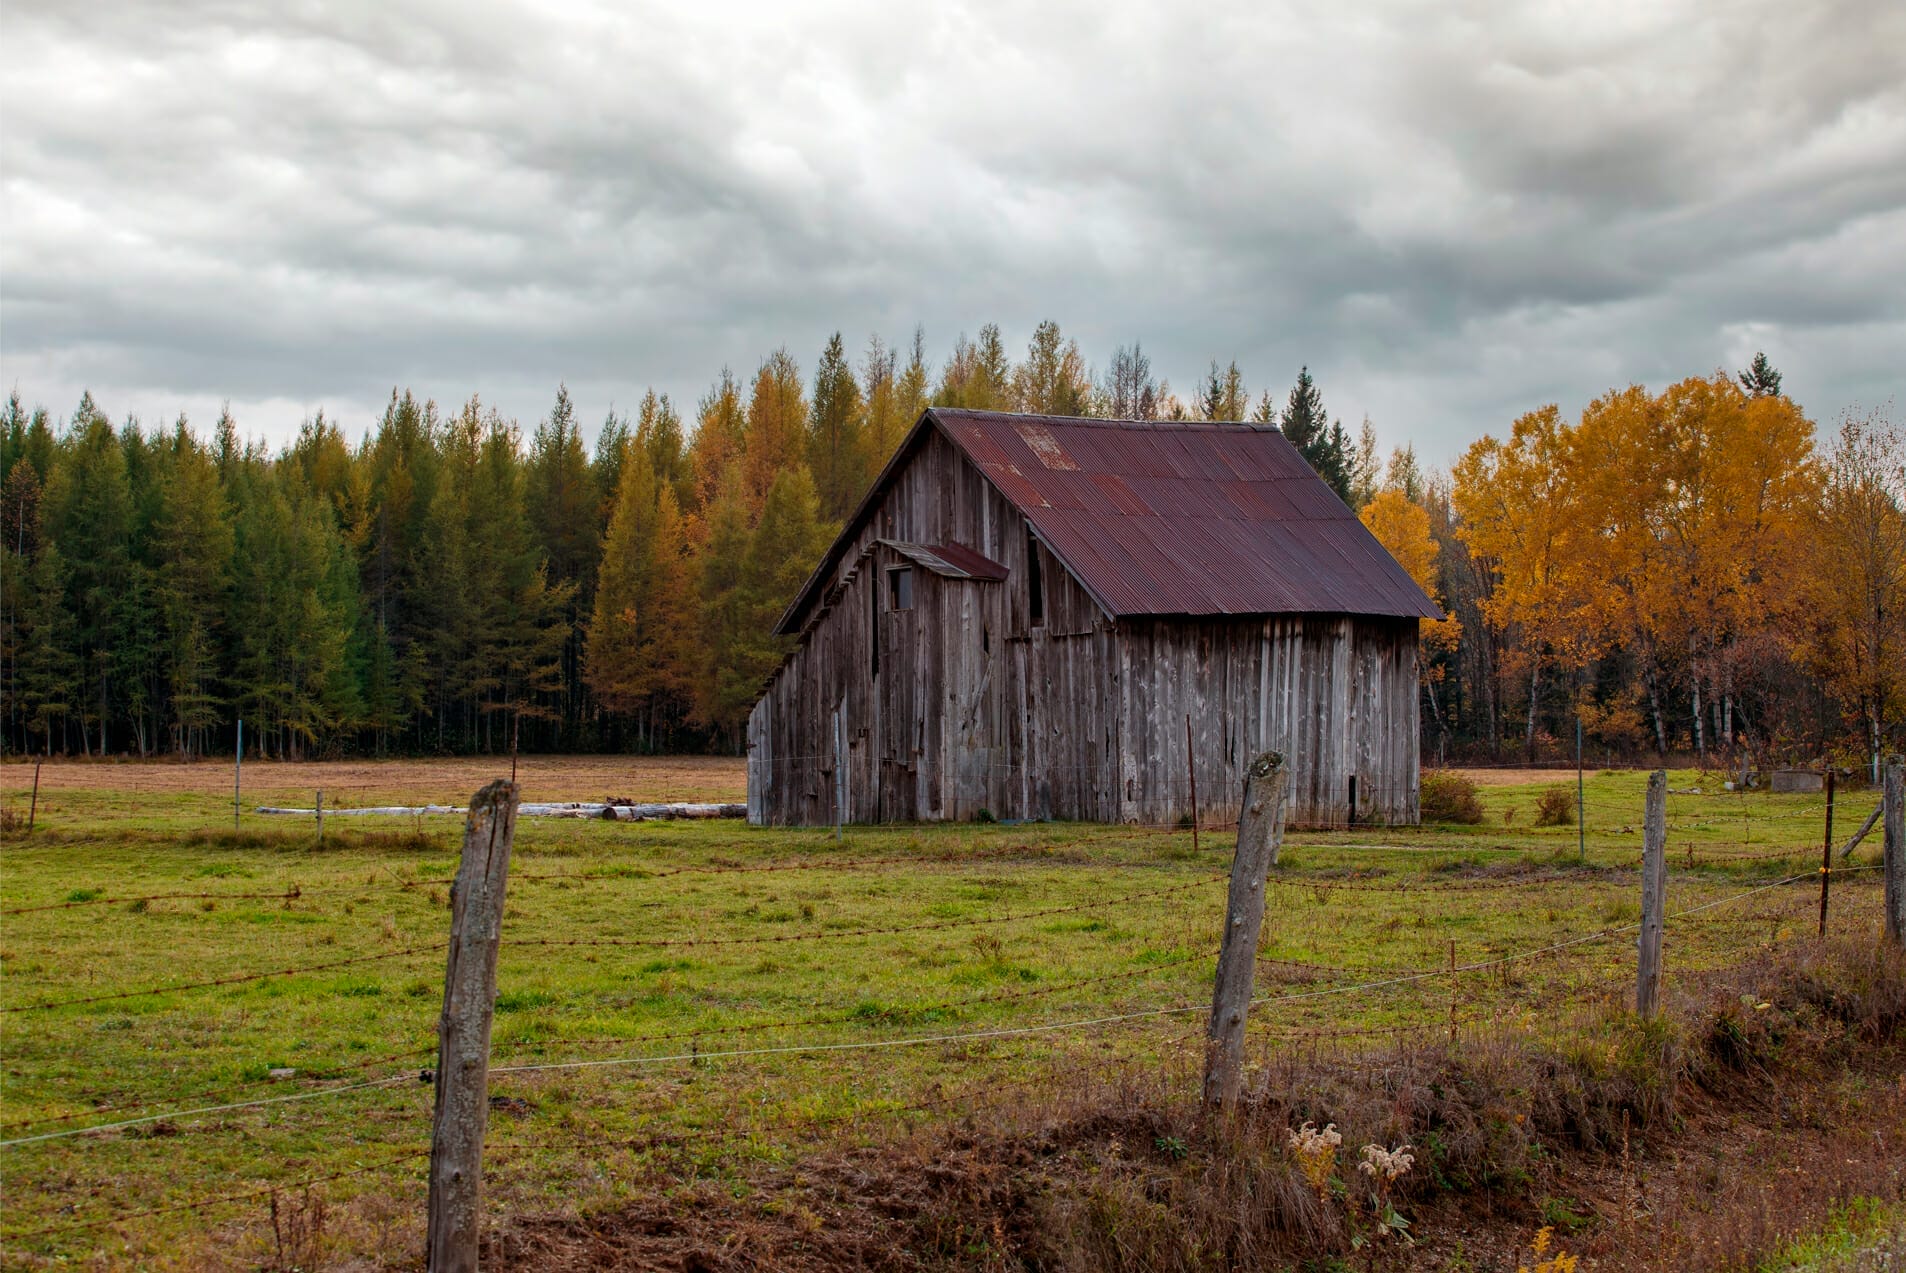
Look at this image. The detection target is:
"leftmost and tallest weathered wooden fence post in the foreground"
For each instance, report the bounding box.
[425,781,517,1273]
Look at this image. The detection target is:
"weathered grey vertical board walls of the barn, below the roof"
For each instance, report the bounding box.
[747,433,1418,825]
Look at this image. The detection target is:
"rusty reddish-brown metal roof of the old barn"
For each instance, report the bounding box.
[776,408,1443,633]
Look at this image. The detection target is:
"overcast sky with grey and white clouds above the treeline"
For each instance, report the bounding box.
[0,0,1906,463]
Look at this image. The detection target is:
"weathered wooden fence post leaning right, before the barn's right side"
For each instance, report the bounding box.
[1205,751,1290,1105]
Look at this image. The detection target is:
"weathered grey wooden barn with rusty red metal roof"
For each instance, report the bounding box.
[747,408,1439,825]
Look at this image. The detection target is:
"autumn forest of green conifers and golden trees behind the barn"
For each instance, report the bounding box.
[0,322,1906,770]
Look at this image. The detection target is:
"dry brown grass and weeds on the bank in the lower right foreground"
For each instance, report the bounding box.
[490,940,1906,1273]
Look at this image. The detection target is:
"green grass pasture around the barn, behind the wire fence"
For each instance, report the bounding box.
[0,758,1879,1267]
